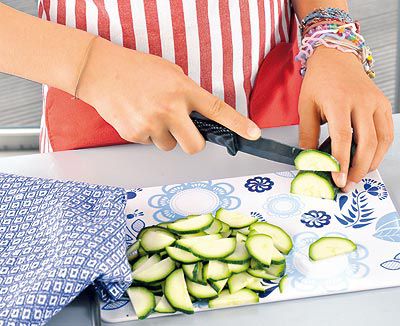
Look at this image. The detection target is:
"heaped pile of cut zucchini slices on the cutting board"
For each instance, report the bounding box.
[127,208,292,319]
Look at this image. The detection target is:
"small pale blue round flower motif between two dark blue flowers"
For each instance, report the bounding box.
[263,194,304,218]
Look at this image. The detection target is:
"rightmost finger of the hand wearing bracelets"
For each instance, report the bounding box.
[370,110,394,171]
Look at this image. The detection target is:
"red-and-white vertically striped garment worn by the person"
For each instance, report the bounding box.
[39,0,291,152]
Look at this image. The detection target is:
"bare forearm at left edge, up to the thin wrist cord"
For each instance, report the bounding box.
[0,3,93,94]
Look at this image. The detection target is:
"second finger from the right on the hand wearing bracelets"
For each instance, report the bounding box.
[345,112,378,191]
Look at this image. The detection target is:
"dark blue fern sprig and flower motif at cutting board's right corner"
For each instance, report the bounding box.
[335,179,388,229]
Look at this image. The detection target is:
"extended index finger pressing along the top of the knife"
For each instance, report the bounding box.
[189,85,261,140]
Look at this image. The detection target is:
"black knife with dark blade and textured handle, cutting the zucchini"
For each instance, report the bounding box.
[191,114,302,165]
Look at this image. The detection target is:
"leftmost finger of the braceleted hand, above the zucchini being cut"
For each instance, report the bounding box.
[299,102,321,149]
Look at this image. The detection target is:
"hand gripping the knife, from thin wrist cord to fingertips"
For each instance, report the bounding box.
[77,38,261,154]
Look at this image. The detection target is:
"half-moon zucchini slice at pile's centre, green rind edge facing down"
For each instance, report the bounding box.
[189,238,236,260]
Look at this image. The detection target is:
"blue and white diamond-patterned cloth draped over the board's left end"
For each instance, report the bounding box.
[0,173,131,326]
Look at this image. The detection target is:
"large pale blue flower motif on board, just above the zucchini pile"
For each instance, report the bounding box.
[148,181,241,222]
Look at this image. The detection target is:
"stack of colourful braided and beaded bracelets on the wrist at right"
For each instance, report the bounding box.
[296,8,375,78]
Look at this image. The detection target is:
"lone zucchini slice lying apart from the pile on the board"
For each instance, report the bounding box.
[308,237,357,260]
